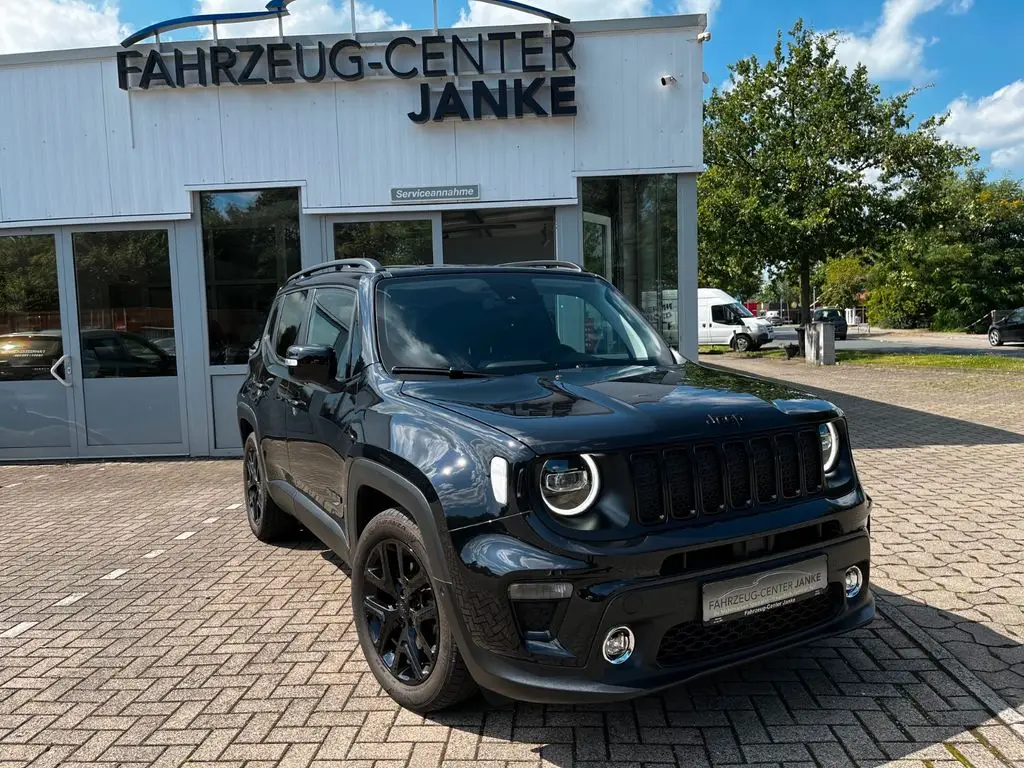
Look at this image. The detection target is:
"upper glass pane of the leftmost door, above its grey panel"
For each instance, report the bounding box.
[0,234,63,381]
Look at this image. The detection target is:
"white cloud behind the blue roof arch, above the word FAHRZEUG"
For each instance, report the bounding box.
[197,0,408,38]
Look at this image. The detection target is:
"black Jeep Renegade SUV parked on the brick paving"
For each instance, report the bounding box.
[238,259,874,712]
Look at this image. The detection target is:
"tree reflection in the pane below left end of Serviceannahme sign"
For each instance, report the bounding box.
[334,220,434,265]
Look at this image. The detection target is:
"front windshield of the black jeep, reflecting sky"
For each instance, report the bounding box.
[377,272,673,375]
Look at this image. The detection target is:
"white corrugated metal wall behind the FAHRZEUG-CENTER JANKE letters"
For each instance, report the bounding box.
[0,20,702,226]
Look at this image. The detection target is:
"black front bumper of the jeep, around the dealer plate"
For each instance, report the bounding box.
[442,520,874,703]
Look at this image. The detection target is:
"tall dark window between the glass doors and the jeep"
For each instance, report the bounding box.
[200,188,302,366]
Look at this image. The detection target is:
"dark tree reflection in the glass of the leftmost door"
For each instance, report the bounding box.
[0,234,60,333]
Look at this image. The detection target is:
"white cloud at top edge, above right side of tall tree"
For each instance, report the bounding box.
[836,0,942,80]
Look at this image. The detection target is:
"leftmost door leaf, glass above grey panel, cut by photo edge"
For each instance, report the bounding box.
[0,233,77,459]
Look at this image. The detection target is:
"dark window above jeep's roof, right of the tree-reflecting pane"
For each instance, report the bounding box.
[441,208,555,265]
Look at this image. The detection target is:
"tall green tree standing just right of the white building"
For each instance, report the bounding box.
[699,22,975,327]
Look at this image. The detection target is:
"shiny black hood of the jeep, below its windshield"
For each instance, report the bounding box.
[401,362,839,454]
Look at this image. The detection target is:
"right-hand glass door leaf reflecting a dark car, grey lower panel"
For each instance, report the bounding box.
[66,228,187,456]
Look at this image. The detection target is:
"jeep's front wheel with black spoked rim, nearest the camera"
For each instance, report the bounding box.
[352,509,476,714]
